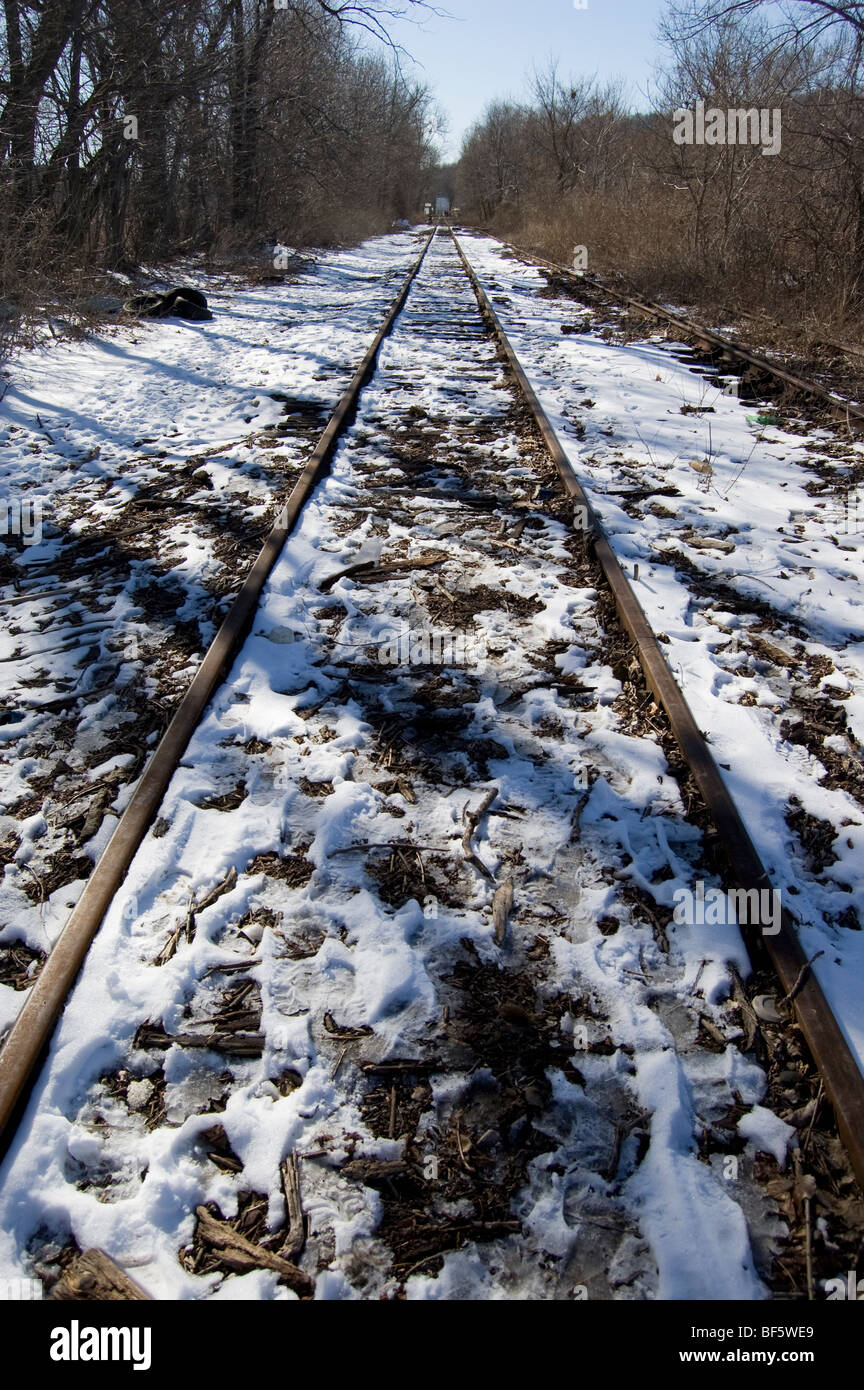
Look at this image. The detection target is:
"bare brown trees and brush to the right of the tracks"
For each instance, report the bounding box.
[458,0,864,325]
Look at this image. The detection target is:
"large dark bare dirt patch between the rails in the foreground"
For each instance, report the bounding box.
[361,948,591,1280]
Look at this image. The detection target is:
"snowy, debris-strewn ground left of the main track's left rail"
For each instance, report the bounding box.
[0,234,427,1038]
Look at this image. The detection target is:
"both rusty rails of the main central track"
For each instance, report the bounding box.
[6,222,864,1186]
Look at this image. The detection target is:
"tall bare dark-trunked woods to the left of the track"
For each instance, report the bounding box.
[0,0,433,328]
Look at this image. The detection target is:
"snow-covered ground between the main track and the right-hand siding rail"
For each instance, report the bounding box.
[464,236,864,1068]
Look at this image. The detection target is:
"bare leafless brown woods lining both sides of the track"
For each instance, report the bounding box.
[6,0,864,327]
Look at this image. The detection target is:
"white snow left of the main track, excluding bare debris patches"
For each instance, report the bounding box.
[0,227,427,1038]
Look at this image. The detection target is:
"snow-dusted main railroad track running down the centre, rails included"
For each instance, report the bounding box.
[0,222,864,1298]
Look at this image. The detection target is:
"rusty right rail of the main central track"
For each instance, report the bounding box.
[453,234,864,1188]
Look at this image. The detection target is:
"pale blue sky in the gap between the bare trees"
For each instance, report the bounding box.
[388,0,675,158]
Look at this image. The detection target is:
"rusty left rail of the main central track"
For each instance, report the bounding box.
[0,232,436,1138]
